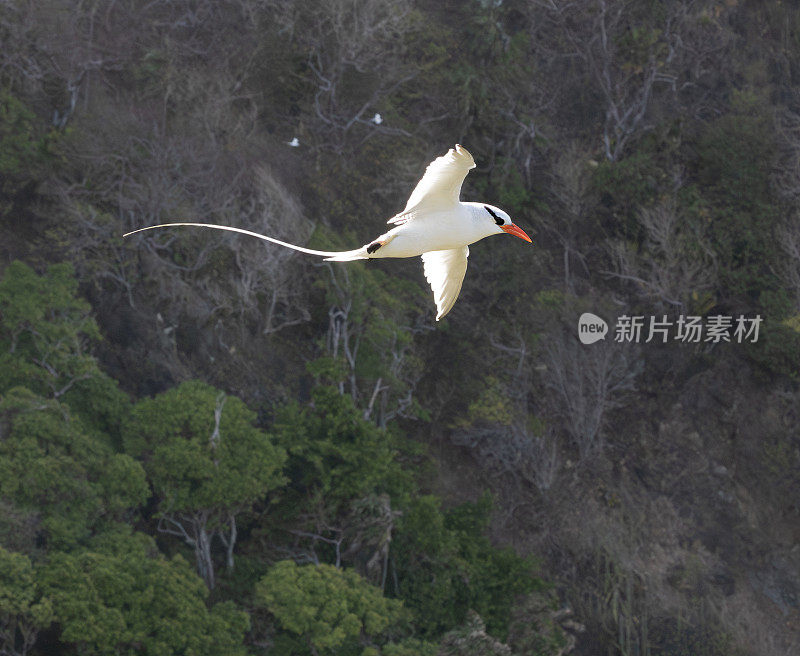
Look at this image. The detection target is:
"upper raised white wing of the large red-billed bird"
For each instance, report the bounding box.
[388,144,475,224]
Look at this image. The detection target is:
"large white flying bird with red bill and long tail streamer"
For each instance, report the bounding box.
[124,144,531,321]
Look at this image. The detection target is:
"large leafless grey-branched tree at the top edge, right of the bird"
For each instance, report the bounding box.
[528,0,731,161]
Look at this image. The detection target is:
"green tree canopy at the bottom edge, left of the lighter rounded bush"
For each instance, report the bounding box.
[40,530,249,656]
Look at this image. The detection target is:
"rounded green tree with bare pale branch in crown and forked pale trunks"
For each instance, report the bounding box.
[123,382,286,587]
